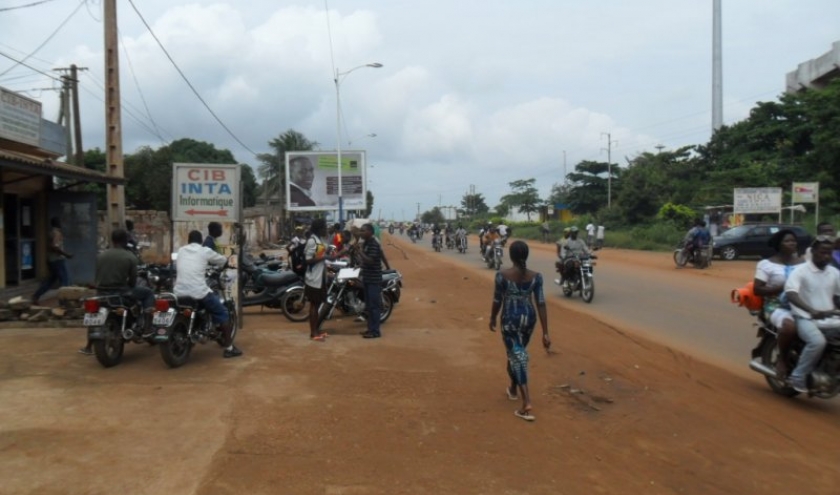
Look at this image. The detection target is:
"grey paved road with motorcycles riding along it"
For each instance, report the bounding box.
[404,235,757,375]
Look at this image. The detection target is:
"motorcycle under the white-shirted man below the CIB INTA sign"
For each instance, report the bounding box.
[152,267,239,368]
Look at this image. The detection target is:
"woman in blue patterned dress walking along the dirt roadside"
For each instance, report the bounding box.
[490,241,551,421]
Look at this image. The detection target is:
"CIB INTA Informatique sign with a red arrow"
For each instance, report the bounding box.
[172,163,241,222]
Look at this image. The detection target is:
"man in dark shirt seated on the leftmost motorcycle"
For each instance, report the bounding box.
[79,229,155,355]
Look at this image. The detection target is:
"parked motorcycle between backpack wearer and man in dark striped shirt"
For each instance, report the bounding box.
[318,261,402,328]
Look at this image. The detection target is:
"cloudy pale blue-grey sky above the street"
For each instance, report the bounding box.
[0,0,840,220]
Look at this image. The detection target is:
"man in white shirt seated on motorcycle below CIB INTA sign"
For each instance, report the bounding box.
[172,230,242,358]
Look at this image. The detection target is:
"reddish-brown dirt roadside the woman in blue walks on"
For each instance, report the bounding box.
[0,238,840,494]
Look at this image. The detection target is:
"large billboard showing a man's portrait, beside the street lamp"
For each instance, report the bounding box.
[286,151,367,211]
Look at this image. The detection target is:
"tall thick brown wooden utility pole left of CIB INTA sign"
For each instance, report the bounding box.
[102,0,125,232]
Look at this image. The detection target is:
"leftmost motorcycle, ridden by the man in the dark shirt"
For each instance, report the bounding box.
[82,294,154,368]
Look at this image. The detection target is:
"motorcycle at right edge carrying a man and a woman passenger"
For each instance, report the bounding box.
[750,310,840,399]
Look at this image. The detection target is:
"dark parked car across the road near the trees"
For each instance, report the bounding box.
[712,223,813,261]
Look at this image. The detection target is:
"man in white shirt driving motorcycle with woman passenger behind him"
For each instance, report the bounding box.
[785,235,840,393]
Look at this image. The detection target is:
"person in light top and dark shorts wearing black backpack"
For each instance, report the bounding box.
[303,218,333,342]
